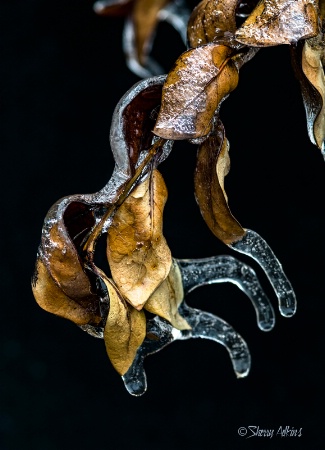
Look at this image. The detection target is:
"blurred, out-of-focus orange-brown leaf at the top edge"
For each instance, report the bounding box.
[132,0,170,65]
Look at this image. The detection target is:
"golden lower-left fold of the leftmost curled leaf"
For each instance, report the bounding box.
[32,258,100,325]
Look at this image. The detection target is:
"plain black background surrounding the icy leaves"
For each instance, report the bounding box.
[0,0,325,450]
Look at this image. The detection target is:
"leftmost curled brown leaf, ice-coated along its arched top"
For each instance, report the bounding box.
[33,196,101,325]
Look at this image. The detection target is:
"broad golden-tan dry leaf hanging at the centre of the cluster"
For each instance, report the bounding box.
[107,170,172,310]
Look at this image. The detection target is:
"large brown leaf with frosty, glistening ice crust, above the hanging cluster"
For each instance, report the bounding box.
[154,44,238,140]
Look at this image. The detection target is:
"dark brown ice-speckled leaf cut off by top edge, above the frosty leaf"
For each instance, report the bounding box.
[187,0,238,48]
